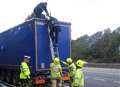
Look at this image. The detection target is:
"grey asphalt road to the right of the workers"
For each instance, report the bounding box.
[83,67,120,87]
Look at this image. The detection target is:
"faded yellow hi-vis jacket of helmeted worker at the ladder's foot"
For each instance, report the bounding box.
[50,63,62,78]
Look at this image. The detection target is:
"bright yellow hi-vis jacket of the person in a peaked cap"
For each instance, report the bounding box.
[20,62,30,79]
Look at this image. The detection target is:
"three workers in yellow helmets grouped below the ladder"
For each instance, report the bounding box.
[50,57,86,87]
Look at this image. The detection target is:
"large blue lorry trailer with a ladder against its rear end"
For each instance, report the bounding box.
[0,18,71,84]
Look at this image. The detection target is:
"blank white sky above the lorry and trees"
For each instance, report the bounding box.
[0,0,120,40]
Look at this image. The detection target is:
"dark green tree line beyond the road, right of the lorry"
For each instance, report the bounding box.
[71,27,120,63]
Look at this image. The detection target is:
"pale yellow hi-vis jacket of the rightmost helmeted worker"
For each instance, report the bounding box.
[72,69,84,87]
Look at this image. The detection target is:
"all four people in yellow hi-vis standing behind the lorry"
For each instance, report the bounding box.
[20,56,86,87]
